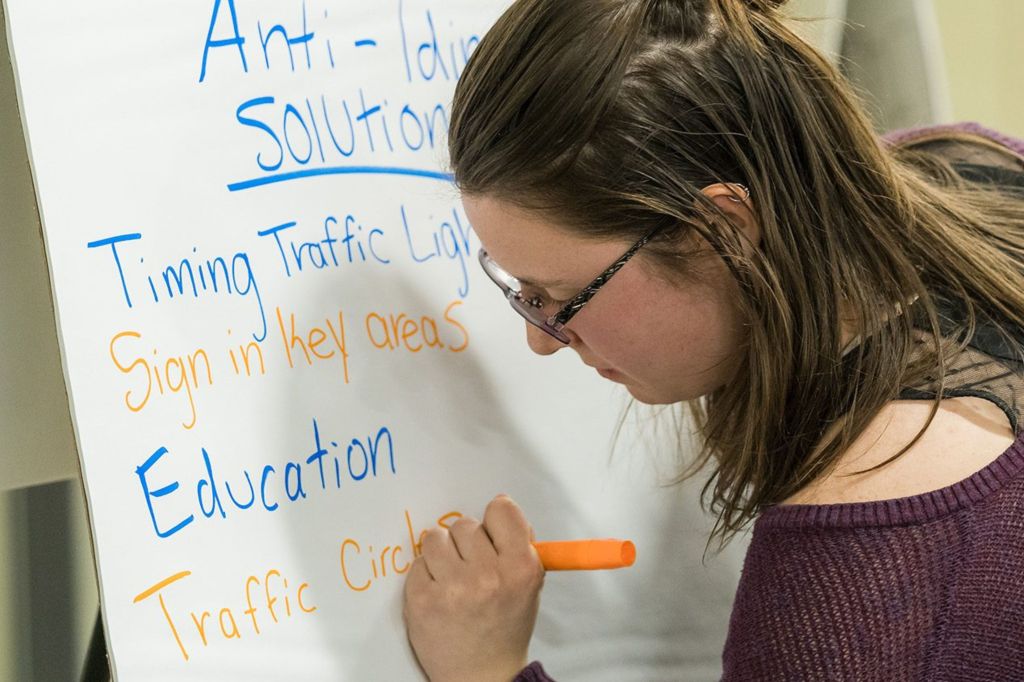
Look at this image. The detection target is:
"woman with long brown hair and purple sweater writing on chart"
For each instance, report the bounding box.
[406,0,1024,681]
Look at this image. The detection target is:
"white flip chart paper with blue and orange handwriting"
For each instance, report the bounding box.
[5,0,745,681]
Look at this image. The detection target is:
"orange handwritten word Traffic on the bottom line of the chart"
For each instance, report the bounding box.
[132,568,316,660]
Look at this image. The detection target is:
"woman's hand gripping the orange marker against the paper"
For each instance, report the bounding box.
[404,496,544,682]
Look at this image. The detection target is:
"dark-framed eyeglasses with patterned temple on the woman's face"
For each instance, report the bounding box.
[478,227,662,344]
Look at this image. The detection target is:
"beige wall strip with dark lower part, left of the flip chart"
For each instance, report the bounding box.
[0,3,97,682]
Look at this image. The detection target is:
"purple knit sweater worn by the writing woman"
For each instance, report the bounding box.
[515,124,1024,682]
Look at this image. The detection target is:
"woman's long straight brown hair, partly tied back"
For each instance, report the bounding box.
[450,0,1024,540]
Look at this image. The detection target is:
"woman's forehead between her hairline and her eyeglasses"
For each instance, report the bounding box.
[462,196,623,284]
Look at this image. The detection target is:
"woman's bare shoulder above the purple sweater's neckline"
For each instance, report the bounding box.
[785,397,1014,504]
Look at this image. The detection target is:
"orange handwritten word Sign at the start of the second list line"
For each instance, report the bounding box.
[110,330,213,429]
